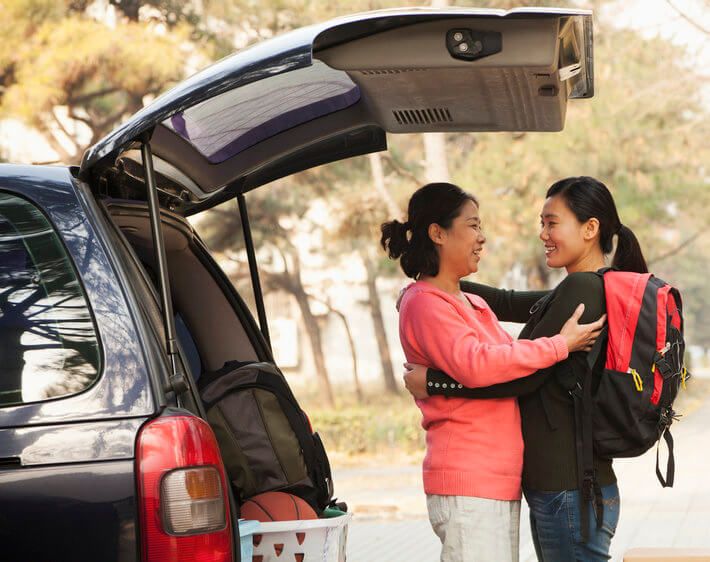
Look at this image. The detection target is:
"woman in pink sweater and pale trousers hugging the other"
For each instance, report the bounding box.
[381,183,603,562]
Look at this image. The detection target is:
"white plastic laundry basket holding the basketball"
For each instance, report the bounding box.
[250,513,352,562]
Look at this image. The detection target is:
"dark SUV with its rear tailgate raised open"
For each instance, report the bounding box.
[0,9,593,562]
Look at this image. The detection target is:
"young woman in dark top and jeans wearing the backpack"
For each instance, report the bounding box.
[405,177,648,562]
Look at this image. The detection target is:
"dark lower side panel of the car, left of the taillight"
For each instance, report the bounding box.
[0,460,139,562]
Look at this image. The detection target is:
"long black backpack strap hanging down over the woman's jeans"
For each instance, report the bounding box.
[570,327,607,543]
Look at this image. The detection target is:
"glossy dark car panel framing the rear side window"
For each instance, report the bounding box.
[0,165,156,428]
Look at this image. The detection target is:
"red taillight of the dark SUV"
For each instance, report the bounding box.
[136,415,232,562]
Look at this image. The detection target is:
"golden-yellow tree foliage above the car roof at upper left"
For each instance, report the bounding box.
[0,0,189,164]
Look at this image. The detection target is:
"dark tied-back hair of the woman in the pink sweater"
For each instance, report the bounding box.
[380,183,478,279]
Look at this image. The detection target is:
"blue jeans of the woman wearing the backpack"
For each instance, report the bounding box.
[525,484,621,562]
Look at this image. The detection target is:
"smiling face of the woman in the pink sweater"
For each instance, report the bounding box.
[430,200,486,277]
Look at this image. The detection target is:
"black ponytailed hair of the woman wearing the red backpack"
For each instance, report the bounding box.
[547,176,648,273]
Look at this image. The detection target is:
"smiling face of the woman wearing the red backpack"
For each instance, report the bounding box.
[540,195,599,272]
